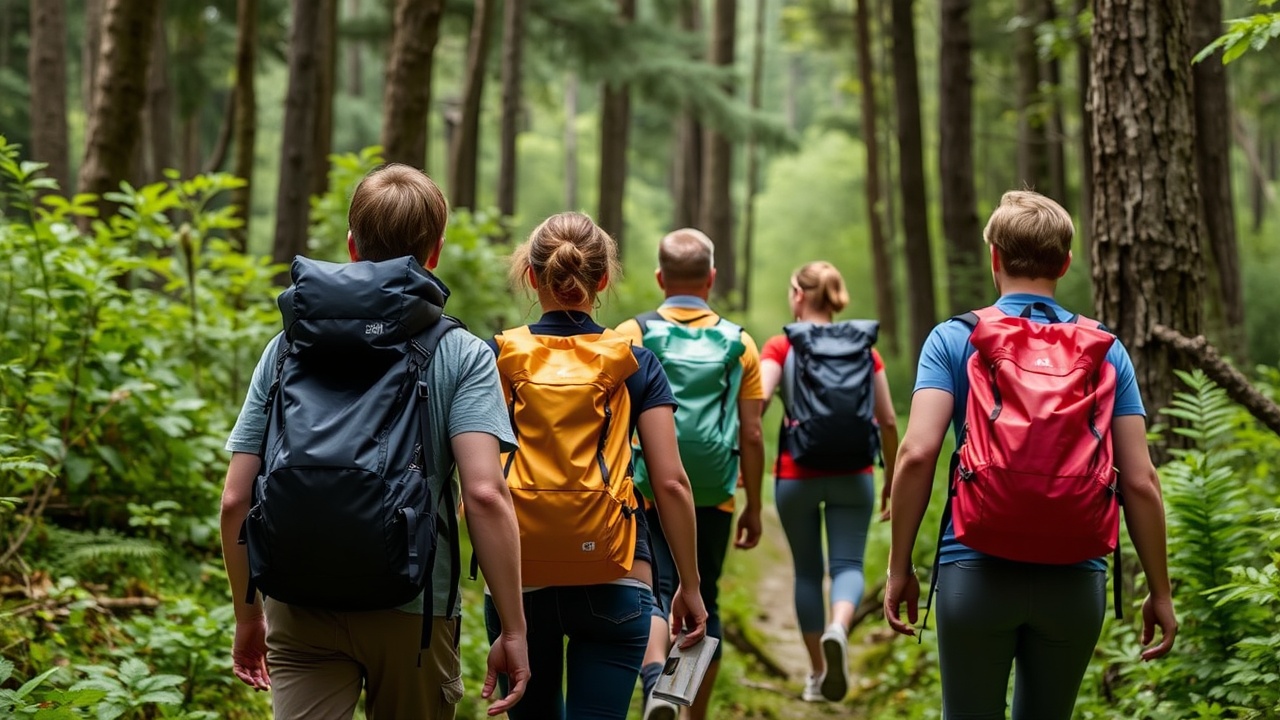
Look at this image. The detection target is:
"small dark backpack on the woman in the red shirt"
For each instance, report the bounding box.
[780,320,879,471]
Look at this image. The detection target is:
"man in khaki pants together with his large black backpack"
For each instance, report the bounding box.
[221,164,529,720]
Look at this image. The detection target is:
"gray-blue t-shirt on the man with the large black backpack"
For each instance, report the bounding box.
[227,328,516,616]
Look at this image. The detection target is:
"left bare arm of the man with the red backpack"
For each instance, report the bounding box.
[884,388,955,635]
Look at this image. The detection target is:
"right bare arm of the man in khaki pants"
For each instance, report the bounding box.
[451,432,529,715]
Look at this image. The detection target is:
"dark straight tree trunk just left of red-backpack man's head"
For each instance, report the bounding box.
[938,0,991,314]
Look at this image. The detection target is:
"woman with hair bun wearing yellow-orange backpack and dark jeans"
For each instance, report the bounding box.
[485,213,707,720]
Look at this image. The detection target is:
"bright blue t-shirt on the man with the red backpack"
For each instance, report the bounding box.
[915,293,1147,570]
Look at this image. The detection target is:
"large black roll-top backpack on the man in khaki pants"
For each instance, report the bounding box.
[241,258,461,647]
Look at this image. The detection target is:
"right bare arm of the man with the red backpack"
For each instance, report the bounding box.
[1111,415,1178,660]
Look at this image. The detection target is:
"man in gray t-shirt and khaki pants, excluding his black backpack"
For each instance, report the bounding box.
[221,164,529,720]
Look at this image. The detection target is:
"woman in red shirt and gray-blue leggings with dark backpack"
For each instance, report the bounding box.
[760,260,897,702]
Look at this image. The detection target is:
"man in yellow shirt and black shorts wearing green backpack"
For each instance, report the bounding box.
[618,228,764,720]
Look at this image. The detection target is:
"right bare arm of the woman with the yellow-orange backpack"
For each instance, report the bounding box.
[636,405,707,647]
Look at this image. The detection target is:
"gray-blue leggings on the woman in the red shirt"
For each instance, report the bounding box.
[773,473,876,633]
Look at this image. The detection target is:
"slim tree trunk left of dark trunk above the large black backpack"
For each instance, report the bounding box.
[230,0,257,251]
